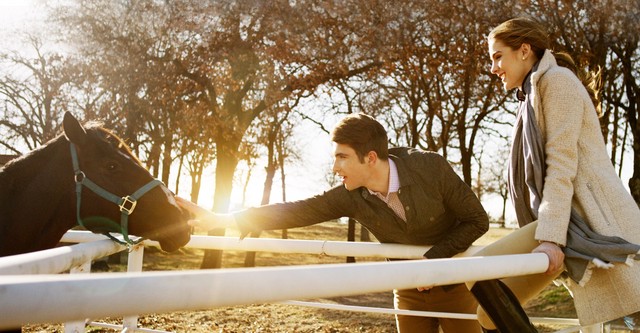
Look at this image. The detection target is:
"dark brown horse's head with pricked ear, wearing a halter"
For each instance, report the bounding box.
[63,112,190,251]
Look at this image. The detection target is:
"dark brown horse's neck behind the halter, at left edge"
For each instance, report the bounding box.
[0,139,75,255]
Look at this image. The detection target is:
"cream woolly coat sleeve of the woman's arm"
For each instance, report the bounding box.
[535,68,591,245]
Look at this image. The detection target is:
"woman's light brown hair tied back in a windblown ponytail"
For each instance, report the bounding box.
[487,17,601,115]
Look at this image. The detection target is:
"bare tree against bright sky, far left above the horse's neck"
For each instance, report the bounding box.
[0,36,78,154]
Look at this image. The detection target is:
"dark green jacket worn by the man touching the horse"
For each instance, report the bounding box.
[234,148,489,258]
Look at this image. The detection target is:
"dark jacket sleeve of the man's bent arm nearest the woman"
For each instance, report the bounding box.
[424,157,489,259]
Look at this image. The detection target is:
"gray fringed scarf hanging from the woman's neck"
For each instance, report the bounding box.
[508,64,640,286]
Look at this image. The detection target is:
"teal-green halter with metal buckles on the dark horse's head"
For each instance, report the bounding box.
[70,143,162,247]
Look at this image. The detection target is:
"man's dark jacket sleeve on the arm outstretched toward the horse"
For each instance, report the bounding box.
[233,186,350,237]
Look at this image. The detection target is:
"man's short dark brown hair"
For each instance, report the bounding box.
[331,113,389,162]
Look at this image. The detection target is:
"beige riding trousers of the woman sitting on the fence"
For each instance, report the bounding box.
[467,222,562,329]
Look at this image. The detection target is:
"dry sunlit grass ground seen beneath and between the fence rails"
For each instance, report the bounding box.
[23,222,576,333]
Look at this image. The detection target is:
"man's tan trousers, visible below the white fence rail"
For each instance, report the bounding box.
[393,284,482,333]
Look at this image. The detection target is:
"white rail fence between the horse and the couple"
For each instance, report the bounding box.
[0,231,600,332]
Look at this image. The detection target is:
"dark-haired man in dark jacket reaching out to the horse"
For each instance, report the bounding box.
[183,114,489,333]
